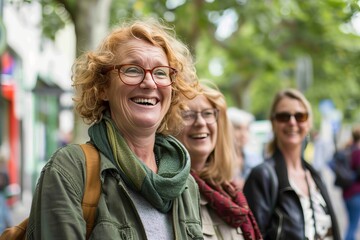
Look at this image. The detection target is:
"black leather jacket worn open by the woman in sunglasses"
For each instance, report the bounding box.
[244,151,341,240]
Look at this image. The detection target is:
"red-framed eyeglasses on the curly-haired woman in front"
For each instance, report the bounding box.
[101,64,177,87]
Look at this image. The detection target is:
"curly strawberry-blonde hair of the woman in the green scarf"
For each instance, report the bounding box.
[72,18,197,134]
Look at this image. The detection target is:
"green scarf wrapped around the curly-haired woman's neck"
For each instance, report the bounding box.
[89,116,190,213]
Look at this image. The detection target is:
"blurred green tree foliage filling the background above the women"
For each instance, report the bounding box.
[23,0,360,127]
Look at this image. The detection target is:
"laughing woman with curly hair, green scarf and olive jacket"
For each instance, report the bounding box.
[27,19,203,240]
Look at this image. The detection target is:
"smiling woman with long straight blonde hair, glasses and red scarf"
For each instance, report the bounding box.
[175,84,262,240]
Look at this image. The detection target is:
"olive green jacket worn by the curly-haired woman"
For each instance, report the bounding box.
[27,144,203,240]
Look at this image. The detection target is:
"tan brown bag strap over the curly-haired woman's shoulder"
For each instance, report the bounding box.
[80,144,101,239]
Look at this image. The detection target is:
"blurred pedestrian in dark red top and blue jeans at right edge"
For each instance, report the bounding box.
[343,124,360,240]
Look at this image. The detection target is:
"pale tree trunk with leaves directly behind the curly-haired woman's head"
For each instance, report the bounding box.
[36,0,112,142]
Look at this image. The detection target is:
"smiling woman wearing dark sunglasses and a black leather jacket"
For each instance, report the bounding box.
[244,89,340,240]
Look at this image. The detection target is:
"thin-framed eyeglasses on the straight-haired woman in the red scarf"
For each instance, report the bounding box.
[181,108,219,126]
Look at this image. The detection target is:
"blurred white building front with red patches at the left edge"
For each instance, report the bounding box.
[0,0,75,202]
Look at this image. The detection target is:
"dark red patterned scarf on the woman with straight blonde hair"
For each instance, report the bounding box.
[191,172,263,240]
